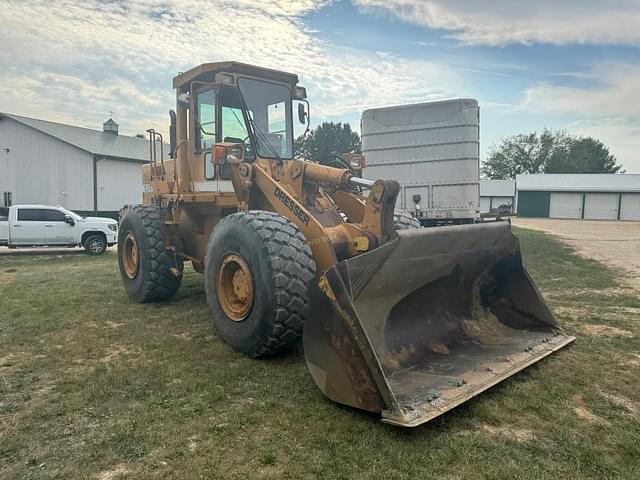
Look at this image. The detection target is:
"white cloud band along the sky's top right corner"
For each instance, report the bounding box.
[354,0,640,45]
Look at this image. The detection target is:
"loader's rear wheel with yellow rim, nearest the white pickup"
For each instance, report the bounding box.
[118,205,183,303]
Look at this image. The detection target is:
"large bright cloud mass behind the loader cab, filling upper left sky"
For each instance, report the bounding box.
[0,0,460,138]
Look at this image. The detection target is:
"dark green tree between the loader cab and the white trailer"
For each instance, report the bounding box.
[296,122,362,163]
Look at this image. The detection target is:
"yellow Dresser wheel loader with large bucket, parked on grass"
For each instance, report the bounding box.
[118,62,573,427]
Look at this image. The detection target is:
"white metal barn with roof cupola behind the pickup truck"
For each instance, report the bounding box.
[0,113,157,215]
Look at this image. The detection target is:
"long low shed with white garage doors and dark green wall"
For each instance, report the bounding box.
[516,173,640,220]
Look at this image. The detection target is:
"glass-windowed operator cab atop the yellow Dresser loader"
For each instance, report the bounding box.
[171,62,309,191]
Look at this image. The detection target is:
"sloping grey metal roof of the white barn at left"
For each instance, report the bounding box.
[0,113,156,162]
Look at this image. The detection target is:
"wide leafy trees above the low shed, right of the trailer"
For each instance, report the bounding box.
[481,129,623,179]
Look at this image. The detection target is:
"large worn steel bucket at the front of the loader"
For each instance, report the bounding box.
[304,222,574,427]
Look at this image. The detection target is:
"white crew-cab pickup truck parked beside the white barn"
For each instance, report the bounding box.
[0,205,118,255]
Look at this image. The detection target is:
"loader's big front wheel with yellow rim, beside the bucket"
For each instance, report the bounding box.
[204,210,316,358]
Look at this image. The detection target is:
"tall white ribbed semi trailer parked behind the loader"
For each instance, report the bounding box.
[360,98,480,226]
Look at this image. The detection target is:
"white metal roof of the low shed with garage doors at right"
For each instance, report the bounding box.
[516,173,640,192]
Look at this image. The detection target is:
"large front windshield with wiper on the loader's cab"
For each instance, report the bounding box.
[238,78,293,159]
